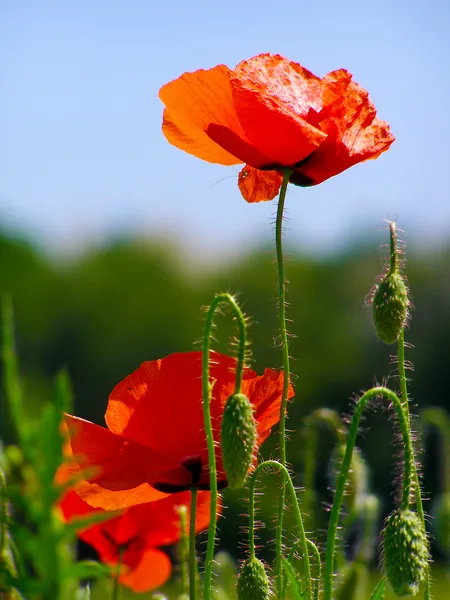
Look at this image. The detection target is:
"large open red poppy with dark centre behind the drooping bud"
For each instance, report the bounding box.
[66,352,294,510]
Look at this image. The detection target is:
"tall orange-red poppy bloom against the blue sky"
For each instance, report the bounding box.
[159,54,395,202]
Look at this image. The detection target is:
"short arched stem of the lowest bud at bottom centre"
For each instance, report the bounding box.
[248,460,312,600]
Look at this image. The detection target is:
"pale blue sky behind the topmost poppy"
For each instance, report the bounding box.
[0,0,450,257]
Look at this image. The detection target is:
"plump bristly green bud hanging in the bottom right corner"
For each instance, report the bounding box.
[383,509,429,596]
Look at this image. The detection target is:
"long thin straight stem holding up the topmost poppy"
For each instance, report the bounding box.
[275,169,292,600]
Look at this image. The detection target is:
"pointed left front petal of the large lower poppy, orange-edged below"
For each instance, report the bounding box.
[65,415,178,509]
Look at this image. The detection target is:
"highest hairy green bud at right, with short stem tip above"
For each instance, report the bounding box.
[372,223,410,344]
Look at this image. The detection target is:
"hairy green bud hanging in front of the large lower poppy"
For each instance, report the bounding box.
[220,394,257,488]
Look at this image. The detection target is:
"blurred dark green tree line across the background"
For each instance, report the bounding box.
[0,233,450,556]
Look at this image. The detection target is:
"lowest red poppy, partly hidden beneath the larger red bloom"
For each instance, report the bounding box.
[60,491,210,592]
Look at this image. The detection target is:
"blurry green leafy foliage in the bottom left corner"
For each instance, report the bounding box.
[0,299,110,600]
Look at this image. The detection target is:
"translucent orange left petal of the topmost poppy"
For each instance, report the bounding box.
[159,65,245,165]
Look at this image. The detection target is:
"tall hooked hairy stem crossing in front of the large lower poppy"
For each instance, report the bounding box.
[202,293,246,600]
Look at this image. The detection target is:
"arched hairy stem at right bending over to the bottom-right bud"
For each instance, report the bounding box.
[323,387,414,600]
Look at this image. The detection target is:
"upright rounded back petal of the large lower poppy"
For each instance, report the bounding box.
[105,352,229,466]
